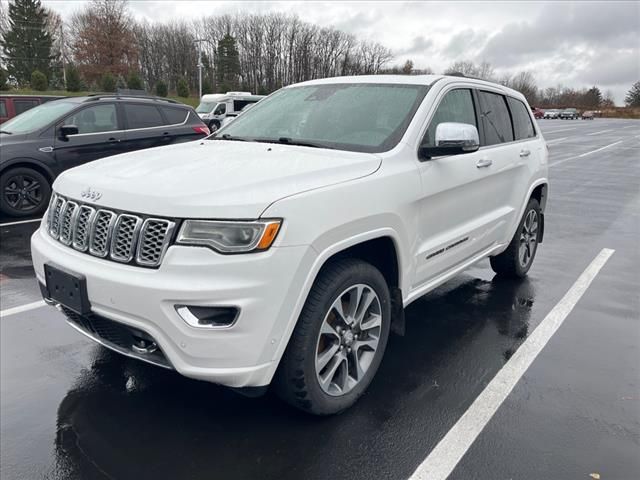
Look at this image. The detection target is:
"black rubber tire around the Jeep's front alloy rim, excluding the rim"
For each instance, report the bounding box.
[302,263,391,414]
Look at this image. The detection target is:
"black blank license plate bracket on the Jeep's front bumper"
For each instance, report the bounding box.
[44,264,91,315]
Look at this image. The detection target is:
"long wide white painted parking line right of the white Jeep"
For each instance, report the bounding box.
[409,248,615,480]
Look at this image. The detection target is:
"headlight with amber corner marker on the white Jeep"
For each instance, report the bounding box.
[176,220,282,253]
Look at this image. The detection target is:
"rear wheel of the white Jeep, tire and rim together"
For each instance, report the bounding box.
[489,198,542,278]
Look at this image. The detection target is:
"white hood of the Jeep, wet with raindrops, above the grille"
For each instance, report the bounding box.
[54,140,381,219]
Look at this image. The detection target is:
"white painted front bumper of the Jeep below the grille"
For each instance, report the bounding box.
[31,229,315,387]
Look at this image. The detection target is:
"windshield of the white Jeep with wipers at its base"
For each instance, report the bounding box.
[210,83,428,152]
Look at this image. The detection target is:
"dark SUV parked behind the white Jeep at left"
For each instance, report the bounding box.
[0,95,209,217]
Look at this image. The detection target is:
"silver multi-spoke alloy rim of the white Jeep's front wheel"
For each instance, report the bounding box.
[315,284,382,396]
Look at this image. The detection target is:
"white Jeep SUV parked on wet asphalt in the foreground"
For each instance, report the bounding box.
[31,75,548,414]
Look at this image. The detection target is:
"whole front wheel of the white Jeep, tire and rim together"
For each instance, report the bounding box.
[274,258,391,415]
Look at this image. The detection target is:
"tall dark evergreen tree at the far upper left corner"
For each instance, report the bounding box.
[0,0,53,85]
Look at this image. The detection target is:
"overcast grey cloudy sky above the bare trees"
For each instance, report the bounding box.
[43,0,640,104]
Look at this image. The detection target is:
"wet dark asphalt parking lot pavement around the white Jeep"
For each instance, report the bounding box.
[0,119,640,480]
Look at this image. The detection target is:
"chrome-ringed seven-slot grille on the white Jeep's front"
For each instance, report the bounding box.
[47,195,175,267]
